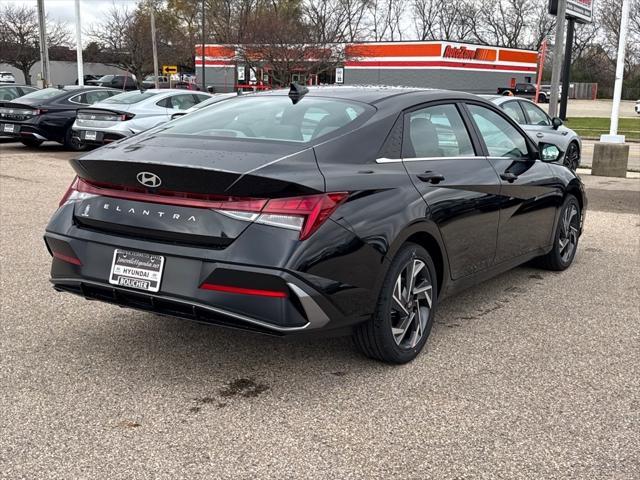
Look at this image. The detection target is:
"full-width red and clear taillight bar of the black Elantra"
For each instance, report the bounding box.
[60,177,349,240]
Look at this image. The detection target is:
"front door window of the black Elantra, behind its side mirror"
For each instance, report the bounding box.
[468,105,528,158]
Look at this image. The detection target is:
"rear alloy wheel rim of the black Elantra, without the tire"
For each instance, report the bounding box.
[391,258,433,349]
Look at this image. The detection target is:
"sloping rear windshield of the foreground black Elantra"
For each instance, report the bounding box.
[163,95,374,142]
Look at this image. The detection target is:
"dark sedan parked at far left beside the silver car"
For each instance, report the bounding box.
[0,87,121,150]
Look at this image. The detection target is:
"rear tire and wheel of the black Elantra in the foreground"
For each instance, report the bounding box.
[353,243,438,364]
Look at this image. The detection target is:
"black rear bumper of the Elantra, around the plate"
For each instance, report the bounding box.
[45,232,358,335]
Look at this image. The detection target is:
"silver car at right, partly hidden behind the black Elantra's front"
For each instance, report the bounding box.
[485,96,582,170]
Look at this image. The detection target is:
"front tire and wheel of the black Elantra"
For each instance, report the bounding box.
[538,194,581,271]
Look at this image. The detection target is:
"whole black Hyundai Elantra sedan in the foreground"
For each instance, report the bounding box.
[45,85,586,363]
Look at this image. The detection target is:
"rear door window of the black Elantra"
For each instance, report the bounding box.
[402,104,475,158]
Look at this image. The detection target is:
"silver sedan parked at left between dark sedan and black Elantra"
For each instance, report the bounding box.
[73,89,211,145]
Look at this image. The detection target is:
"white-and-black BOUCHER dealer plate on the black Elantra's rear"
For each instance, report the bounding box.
[109,249,164,292]
